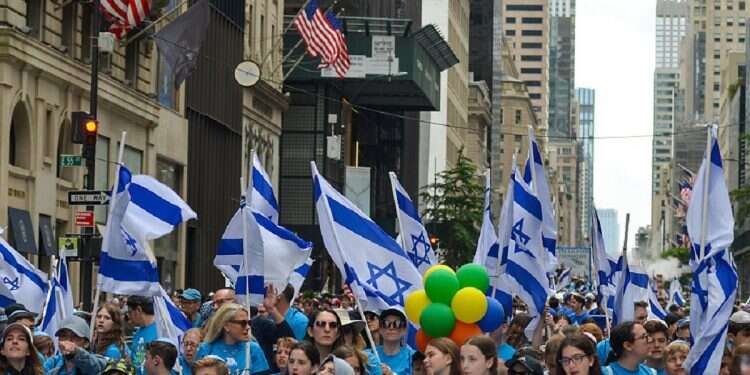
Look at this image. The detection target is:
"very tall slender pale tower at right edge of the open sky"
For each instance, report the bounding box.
[651,0,689,253]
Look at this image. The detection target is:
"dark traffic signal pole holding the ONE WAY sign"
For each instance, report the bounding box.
[79,0,101,316]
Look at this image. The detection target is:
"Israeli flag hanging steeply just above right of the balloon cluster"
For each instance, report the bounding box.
[505,165,551,340]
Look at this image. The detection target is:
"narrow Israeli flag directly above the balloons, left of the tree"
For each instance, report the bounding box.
[388,172,437,274]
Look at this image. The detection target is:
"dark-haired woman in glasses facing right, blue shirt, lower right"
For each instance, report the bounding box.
[602,322,656,375]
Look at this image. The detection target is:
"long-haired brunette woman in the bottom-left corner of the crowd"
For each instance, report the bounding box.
[0,323,44,375]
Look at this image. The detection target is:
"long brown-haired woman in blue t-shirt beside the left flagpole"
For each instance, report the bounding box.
[93,303,127,360]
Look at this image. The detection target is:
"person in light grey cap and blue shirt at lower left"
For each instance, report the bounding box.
[44,315,107,375]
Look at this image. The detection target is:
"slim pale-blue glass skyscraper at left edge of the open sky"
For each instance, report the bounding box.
[576,87,596,239]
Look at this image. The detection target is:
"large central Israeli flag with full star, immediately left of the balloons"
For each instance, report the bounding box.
[311,162,422,310]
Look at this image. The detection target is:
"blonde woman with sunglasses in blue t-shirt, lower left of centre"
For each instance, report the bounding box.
[196,302,271,374]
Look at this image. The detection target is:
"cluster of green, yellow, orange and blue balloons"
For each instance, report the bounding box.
[404,263,505,351]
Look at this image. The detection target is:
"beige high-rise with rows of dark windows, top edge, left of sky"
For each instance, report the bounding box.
[502,0,550,137]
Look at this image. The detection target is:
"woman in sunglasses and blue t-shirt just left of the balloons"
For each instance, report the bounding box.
[375,308,414,375]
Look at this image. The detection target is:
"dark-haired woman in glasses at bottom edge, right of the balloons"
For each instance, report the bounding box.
[557,334,602,375]
